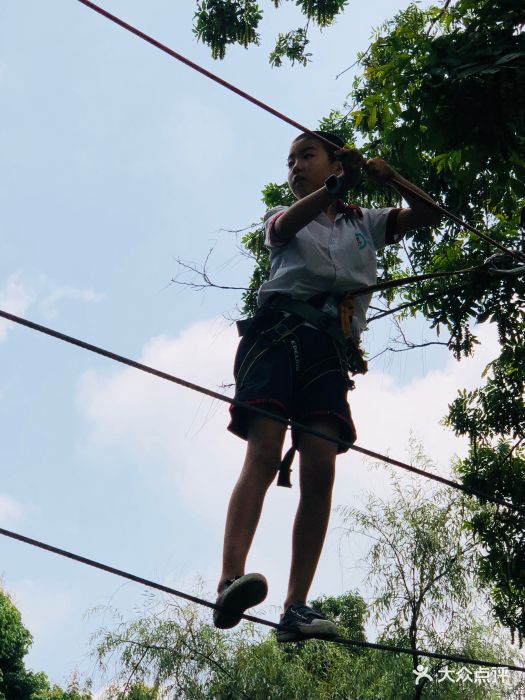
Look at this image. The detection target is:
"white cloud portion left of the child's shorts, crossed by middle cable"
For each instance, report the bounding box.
[78,319,242,516]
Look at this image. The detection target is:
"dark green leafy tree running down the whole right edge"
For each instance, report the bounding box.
[344,0,525,633]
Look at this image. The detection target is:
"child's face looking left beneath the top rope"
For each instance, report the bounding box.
[288,138,341,199]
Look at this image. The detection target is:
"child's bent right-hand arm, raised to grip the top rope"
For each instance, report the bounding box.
[364,158,441,236]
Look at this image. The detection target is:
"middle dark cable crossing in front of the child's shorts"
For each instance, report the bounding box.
[0,309,525,515]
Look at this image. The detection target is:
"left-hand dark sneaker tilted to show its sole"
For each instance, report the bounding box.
[213,574,268,629]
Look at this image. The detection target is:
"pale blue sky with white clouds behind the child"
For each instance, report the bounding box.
[0,0,510,689]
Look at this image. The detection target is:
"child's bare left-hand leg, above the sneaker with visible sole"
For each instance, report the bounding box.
[218,416,286,590]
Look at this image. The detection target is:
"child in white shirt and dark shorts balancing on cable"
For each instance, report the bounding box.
[214,132,439,642]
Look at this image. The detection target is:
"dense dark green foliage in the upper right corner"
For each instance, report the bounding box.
[352,0,525,358]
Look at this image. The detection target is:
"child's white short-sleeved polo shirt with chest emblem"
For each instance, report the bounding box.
[257,203,401,341]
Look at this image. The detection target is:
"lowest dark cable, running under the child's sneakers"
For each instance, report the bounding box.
[0,527,525,673]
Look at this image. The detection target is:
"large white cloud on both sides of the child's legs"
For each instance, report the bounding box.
[74,320,497,604]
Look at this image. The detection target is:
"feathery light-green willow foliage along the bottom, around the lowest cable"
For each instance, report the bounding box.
[92,443,525,700]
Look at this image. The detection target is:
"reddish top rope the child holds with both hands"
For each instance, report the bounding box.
[78,0,524,262]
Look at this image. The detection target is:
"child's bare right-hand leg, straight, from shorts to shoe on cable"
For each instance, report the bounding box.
[284,418,339,610]
